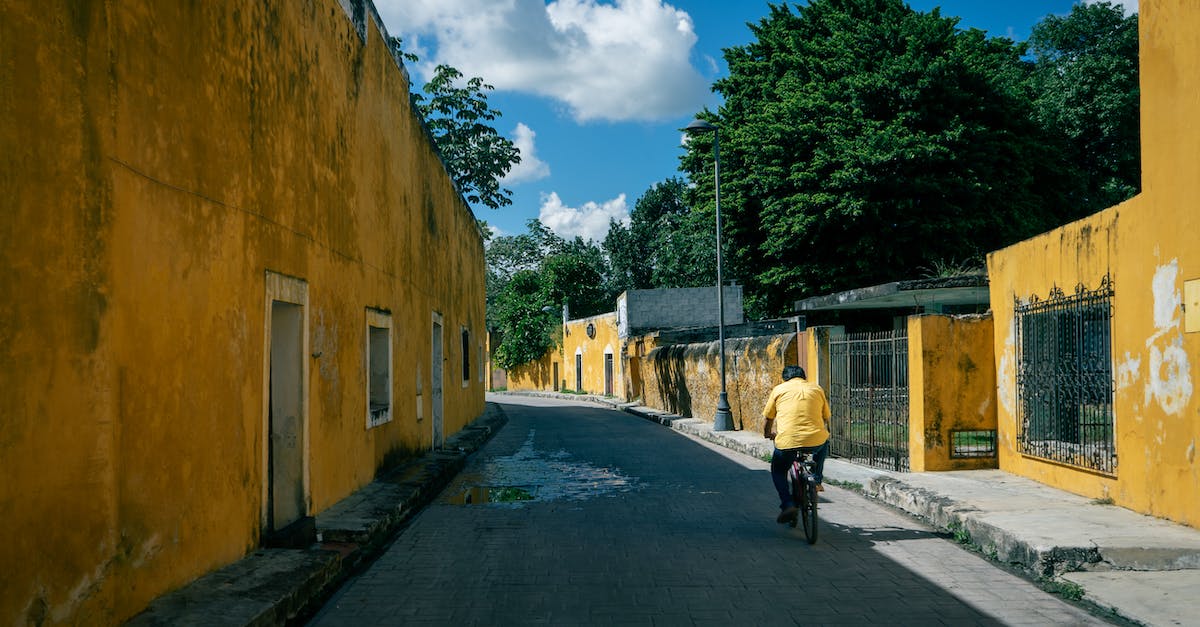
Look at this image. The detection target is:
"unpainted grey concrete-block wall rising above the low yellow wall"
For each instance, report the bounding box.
[617,285,744,338]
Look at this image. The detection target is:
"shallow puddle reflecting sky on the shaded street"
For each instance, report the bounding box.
[443,430,640,506]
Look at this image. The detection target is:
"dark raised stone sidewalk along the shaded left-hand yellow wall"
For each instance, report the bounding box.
[126,402,508,627]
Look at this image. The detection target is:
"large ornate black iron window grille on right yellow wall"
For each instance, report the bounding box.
[1016,276,1117,474]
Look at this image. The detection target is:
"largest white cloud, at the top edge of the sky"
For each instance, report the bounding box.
[376,0,709,121]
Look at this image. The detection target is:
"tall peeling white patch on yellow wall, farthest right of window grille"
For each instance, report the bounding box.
[1145,259,1192,416]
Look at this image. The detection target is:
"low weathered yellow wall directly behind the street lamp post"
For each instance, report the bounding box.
[642,333,809,431]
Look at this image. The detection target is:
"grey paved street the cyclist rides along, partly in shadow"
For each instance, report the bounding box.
[312,398,1104,627]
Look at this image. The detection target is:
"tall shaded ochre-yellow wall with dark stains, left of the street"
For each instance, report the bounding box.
[0,0,485,623]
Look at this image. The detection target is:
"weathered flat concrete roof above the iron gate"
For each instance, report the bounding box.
[796,274,990,312]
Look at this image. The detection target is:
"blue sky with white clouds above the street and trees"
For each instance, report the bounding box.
[374,0,1138,240]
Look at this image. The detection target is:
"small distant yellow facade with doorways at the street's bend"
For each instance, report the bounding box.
[563,311,625,398]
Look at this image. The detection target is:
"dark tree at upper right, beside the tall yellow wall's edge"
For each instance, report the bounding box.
[1028,2,1141,213]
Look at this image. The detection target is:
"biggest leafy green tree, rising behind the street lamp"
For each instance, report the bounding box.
[682,0,1074,316]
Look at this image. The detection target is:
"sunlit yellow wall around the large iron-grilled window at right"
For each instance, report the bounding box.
[988,0,1200,526]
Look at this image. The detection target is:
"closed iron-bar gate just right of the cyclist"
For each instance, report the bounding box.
[829,329,908,471]
